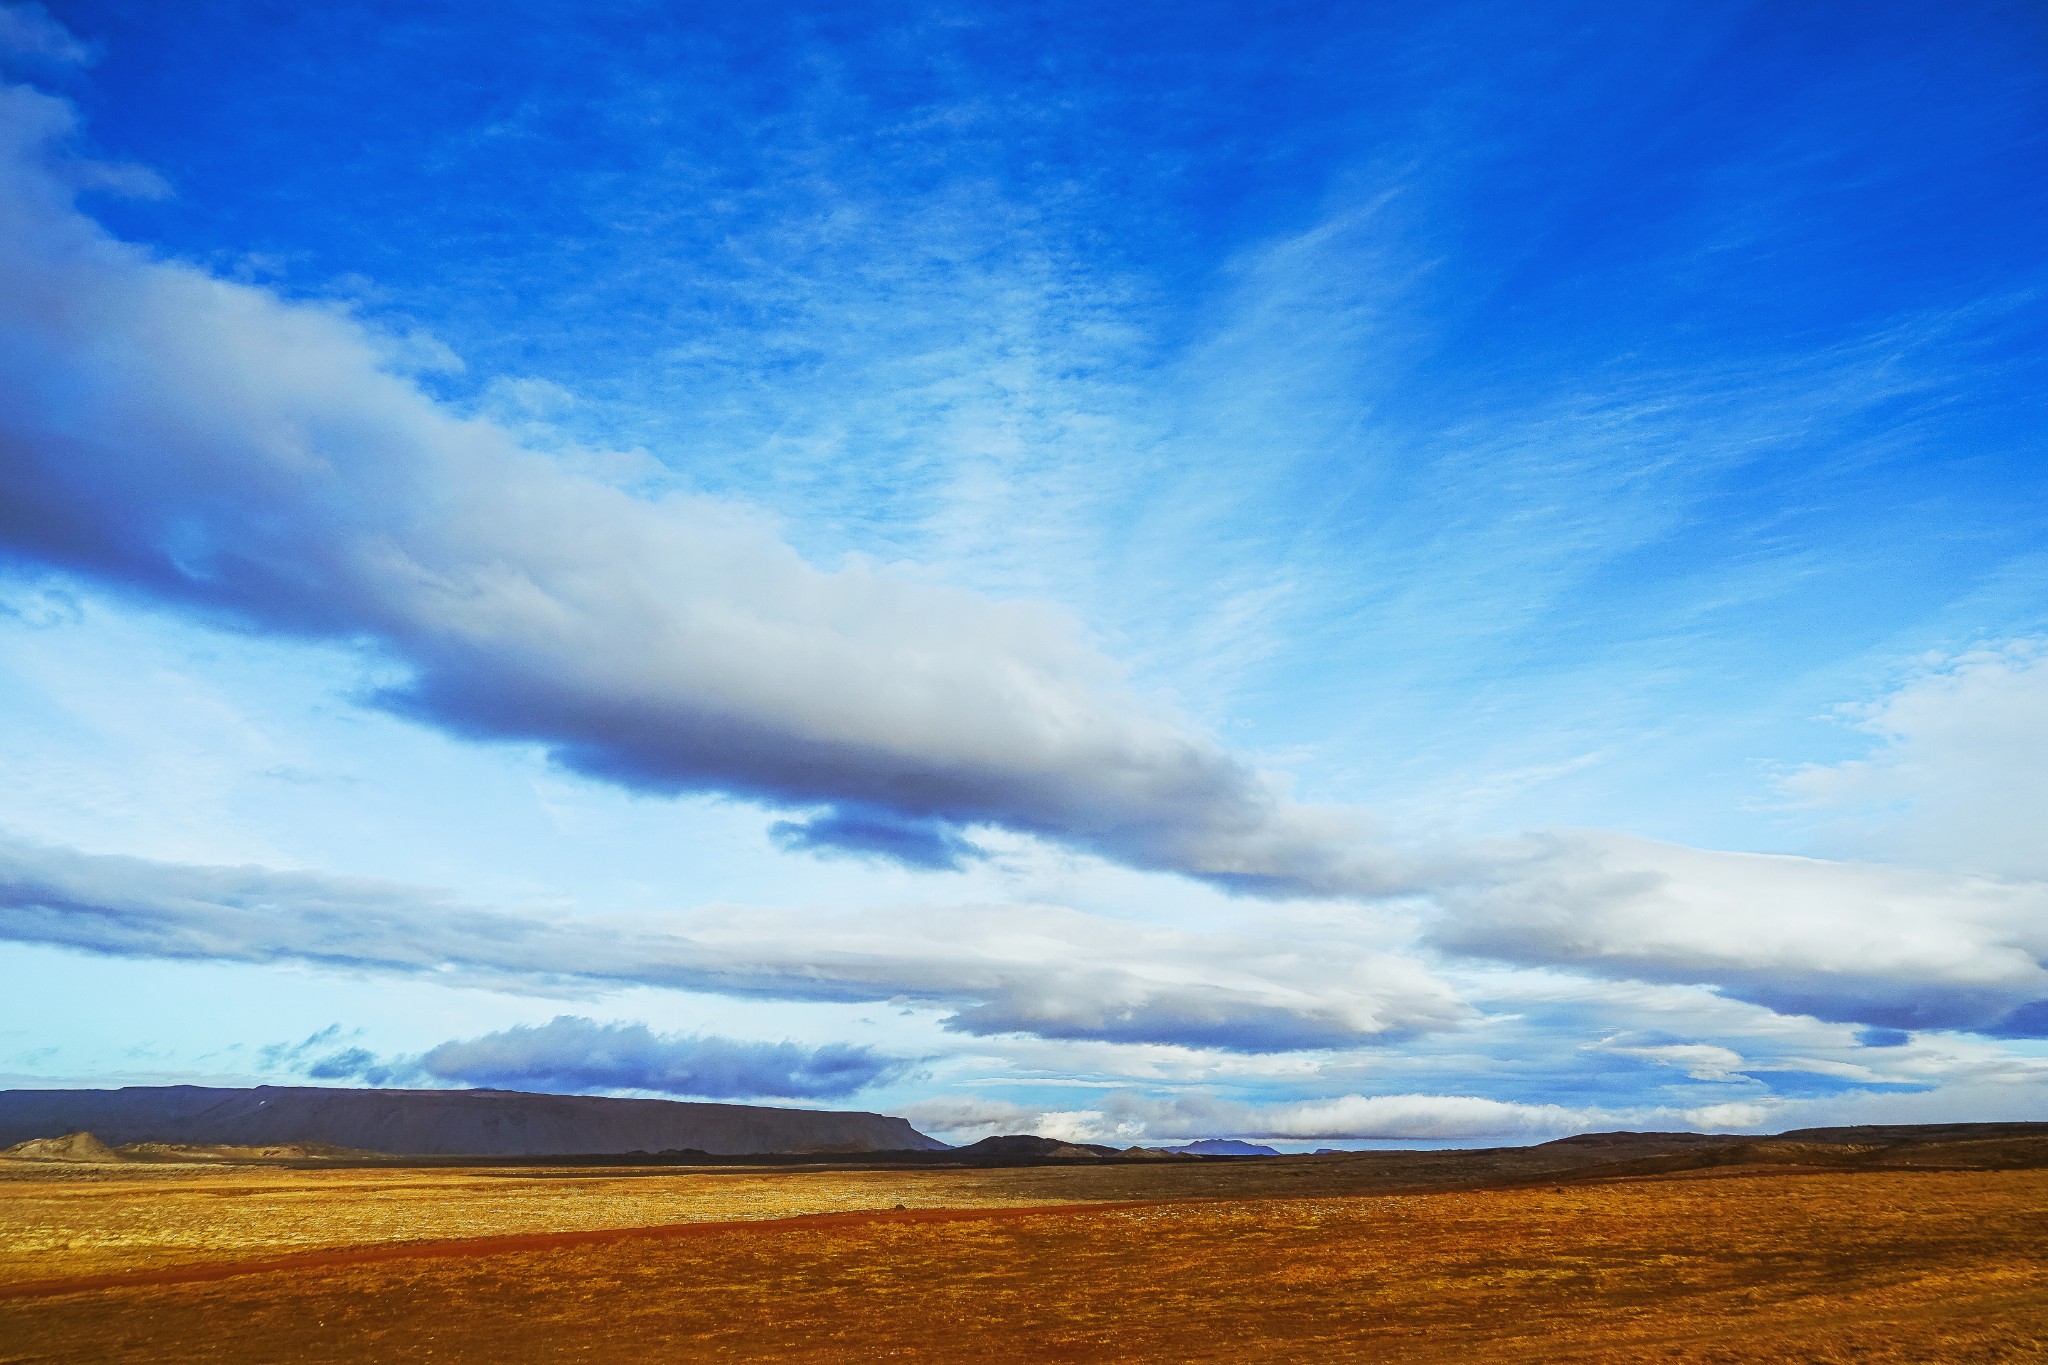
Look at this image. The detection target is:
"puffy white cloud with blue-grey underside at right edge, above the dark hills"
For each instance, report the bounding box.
[1430,833,2048,1038]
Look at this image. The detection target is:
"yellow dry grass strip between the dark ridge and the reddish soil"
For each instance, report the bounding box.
[0,1148,1728,1287]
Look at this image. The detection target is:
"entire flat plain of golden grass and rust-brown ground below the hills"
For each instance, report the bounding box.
[0,1158,2048,1363]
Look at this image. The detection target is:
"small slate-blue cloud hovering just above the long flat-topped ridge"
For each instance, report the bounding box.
[303,1015,909,1099]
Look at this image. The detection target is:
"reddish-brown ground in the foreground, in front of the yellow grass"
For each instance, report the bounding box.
[0,1171,2048,1365]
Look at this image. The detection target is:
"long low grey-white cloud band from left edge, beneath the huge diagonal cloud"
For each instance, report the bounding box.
[0,835,1473,1052]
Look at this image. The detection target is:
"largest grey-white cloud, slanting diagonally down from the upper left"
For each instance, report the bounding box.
[0,86,1407,892]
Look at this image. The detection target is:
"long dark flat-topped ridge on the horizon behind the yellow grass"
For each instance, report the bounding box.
[0,1085,946,1156]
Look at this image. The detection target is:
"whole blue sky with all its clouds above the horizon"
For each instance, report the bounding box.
[0,0,2048,1144]
